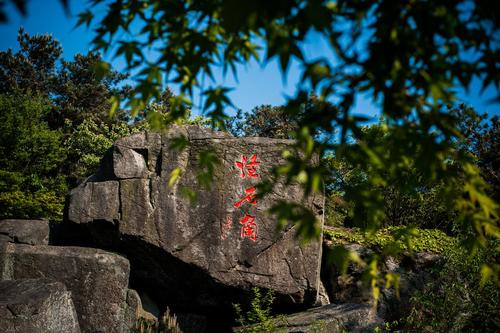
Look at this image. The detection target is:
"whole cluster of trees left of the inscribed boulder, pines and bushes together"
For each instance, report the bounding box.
[0,29,138,220]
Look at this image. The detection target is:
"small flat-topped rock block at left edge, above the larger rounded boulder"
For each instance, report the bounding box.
[0,219,49,245]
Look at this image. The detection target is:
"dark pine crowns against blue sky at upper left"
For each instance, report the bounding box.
[0,28,129,133]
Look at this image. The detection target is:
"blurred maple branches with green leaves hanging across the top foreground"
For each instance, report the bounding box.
[82,0,500,286]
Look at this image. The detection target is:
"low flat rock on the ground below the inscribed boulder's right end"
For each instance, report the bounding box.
[235,303,383,333]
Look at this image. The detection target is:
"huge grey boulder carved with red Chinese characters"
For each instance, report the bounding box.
[65,126,323,320]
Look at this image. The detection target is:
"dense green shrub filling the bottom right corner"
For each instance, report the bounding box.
[405,244,500,333]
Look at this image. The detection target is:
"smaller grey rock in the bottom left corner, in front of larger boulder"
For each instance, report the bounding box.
[0,279,80,333]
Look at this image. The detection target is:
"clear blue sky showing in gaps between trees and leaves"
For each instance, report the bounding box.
[0,0,500,116]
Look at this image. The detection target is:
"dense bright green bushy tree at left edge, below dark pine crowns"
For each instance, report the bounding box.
[0,93,67,219]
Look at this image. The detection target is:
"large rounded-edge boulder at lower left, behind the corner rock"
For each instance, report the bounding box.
[0,243,130,332]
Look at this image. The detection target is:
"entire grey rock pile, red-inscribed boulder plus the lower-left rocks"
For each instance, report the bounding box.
[0,126,323,332]
